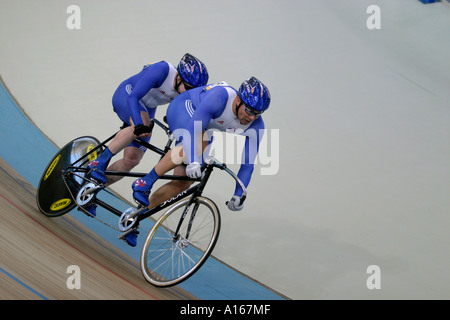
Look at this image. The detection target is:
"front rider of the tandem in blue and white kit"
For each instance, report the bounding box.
[130,77,270,245]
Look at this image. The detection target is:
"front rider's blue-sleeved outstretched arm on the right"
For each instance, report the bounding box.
[234,118,264,197]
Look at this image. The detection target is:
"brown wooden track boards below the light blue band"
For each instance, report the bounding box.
[0,158,197,300]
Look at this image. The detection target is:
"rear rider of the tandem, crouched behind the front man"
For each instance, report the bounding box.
[85,53,209,225]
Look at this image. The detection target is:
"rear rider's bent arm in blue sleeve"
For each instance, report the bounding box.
[127,61,169,125]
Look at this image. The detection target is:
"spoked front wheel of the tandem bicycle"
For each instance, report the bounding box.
[141,196,221,287]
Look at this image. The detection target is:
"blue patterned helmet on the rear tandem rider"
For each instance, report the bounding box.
[177,53,209,87]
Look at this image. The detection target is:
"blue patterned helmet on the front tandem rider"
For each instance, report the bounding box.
[239,77,270,113]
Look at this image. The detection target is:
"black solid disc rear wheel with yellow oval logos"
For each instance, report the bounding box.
[36,136,103,217]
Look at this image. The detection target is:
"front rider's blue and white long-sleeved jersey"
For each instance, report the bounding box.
[167,84,264,196]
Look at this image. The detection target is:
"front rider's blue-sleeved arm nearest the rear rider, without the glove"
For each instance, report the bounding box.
[183,87,228,163]
